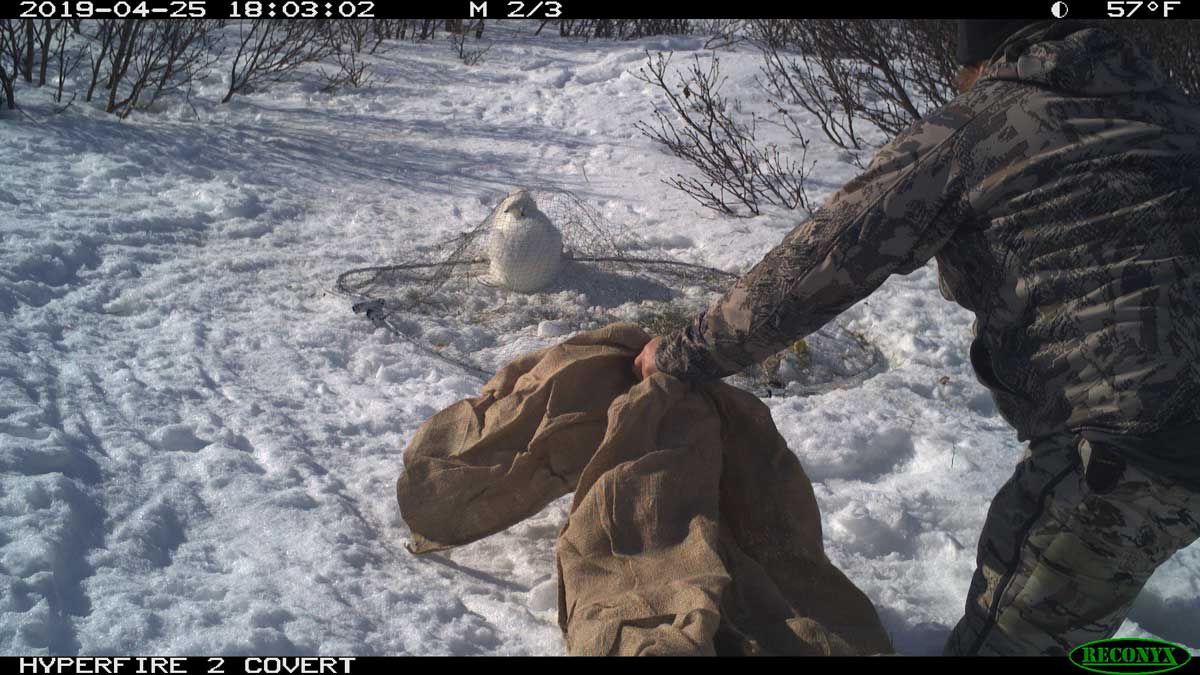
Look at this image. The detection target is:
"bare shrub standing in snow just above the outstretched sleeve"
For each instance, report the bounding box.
[635,54,811,216]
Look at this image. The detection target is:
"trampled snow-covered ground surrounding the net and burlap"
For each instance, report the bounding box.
[0,21,1200,655]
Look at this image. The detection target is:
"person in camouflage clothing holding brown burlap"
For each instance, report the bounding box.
[635,22,1200,655]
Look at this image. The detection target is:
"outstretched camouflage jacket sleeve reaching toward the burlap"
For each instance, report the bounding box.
[655,102,973,381]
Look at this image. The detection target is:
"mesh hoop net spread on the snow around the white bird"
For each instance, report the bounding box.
[336,187,882,395]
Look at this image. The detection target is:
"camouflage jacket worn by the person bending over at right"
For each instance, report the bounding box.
[656,22,1200,478]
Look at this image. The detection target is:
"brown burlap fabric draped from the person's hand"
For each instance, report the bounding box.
[396,324,892,655]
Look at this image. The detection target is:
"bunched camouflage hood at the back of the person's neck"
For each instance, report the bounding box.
[979,22,1168,96]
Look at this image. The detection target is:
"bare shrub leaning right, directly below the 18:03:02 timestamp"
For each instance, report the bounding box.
[221,19,337,103]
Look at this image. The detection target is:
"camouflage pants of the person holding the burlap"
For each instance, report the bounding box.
[944,436,1200,656]
